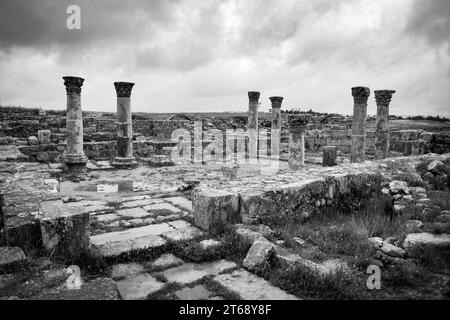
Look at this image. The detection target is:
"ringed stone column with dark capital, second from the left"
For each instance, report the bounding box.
[112,82,137,168]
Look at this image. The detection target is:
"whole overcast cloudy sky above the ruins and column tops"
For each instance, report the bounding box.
[0,0,450,116]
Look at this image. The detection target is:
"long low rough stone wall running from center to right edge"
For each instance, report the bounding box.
[193,153,450,230]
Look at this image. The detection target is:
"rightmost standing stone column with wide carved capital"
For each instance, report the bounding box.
[375,90,395,159]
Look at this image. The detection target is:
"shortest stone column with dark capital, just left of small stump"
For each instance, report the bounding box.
[288,114,308,170]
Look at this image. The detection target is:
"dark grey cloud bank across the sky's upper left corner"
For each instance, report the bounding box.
[0,0,179,49]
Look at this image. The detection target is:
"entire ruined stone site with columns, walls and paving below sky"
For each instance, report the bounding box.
[0,76,450,300]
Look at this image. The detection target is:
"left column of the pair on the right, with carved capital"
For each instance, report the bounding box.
[350,87,370,163]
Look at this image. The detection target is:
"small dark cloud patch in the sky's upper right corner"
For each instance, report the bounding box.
[406,0,450,47]
